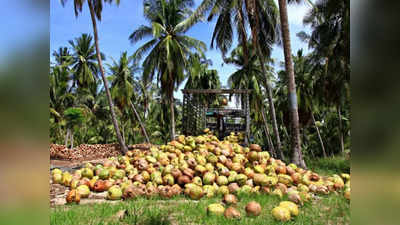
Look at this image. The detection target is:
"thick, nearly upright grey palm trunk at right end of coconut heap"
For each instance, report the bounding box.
[278,0,306,168]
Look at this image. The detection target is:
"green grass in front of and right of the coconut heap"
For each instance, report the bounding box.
[50,159,350,225]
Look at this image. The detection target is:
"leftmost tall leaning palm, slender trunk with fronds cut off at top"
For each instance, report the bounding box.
[61,0,128,153]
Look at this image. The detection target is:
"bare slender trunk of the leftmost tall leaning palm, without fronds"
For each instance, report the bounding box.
[87,0,128,154]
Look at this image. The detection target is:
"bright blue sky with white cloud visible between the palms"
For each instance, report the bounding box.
[50,0,310,99]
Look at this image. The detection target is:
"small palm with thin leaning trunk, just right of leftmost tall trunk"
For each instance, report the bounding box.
[109,51,150,143]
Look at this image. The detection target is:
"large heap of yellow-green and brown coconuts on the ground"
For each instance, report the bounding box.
[51,129,350,221]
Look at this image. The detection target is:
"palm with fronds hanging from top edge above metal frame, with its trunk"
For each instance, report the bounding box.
[179,0,283,158]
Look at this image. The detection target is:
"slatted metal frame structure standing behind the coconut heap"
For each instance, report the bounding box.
[182,89,251,144]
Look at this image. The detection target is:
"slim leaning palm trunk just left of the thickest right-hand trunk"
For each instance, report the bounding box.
[246,1,285,160]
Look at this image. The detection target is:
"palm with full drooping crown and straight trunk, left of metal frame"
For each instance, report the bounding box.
[129,0,206,139]
